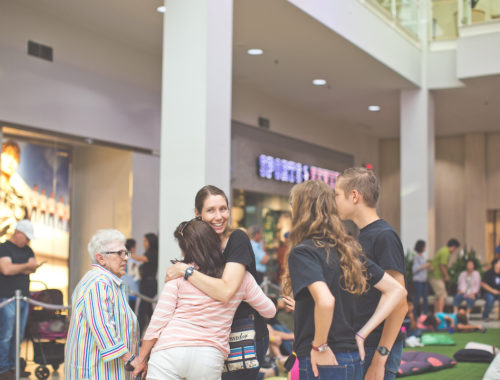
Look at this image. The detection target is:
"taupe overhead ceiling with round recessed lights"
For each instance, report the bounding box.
[9,0,500,137]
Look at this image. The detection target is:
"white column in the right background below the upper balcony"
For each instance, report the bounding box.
[401,89,435,255]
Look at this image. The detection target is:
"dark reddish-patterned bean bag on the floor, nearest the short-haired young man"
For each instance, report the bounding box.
[397,351,457,377]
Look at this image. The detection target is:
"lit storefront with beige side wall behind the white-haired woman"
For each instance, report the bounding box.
[0,123,157,303]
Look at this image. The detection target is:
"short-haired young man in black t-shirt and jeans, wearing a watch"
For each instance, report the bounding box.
[335,168,408,380]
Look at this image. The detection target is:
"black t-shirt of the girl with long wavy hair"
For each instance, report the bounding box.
[288,240,384,358]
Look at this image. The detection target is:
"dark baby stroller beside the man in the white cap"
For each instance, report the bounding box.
[28,289,68,380]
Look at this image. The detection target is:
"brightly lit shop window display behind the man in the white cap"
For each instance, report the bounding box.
[0,139,70,300]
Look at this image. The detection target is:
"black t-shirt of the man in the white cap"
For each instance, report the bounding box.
[0,241,35,298]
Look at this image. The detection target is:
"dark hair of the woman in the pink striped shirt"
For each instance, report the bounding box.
[174,218,226,278]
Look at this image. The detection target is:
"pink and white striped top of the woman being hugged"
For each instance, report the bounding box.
[144,272,276,357]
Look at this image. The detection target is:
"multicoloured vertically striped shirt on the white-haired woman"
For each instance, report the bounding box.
[64,264,139,380]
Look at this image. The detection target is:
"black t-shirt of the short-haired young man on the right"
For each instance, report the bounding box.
[355,219,406,347]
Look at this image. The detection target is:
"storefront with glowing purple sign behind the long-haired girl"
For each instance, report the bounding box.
[231,122,354,251]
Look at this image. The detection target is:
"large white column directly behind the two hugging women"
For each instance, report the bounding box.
[158,0,233,289]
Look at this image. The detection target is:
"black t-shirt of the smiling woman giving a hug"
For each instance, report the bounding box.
[224,230,269,339]
